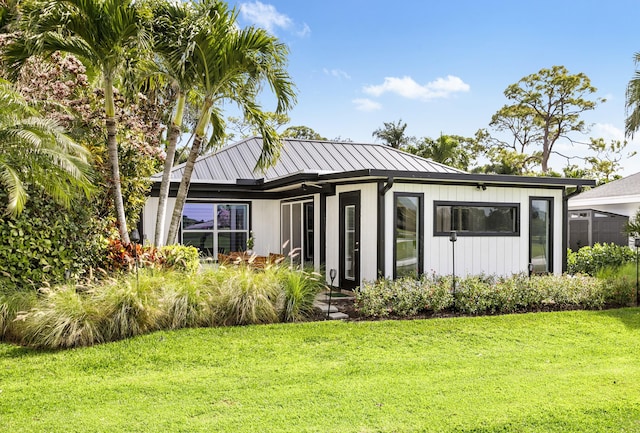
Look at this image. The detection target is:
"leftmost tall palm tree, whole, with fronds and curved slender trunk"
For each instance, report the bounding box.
[5,0,146,244]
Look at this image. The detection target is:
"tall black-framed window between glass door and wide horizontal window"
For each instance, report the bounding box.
[393,193,424,278]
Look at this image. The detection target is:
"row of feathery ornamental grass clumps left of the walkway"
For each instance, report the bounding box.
[0,266,324,348]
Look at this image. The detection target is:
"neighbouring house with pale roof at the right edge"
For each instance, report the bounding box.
[569,173,640,249]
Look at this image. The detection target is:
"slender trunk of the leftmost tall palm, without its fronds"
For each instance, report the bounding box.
[104,78,131,245]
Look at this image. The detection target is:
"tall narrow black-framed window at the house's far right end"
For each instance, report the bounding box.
[529,197,553,273]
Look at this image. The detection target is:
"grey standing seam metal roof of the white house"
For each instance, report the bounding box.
[153,137,465,183]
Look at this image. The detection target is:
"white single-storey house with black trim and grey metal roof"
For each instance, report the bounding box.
[142,138,594,288]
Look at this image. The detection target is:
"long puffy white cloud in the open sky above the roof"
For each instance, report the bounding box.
[362,75,470,101]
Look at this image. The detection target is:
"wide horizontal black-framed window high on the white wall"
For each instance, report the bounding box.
[434,202,520,236]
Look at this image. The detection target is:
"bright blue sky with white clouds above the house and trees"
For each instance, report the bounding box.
[230,0,640,175]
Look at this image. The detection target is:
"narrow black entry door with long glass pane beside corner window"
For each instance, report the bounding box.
[340,191,360,290]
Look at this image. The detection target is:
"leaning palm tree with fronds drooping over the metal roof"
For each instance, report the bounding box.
[167,0,295,244]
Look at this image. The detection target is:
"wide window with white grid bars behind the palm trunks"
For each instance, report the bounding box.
[182,203,249,257]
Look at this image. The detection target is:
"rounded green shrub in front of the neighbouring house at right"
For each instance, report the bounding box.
[567,243,635,275]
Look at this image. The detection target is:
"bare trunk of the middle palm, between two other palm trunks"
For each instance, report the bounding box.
[153,93,186,247]
